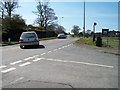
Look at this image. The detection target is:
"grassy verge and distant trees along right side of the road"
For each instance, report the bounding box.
[71,25,120,50]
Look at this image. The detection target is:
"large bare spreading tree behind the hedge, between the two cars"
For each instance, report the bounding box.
[34,0,58,30]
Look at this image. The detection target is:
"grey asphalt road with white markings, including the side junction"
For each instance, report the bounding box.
[0,38,118,88]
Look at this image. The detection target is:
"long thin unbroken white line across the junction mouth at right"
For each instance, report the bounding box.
[45,59,114,68]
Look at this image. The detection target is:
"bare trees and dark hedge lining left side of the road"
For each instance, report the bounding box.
[0,0,66,46]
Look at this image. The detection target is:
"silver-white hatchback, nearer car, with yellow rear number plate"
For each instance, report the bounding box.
[19,31,39,48]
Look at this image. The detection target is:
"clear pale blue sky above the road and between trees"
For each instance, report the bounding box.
[15,0,118,32]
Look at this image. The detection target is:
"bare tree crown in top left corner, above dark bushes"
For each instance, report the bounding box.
[0,0,18,18]
